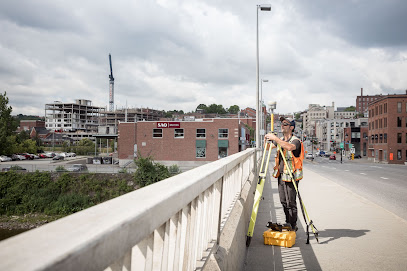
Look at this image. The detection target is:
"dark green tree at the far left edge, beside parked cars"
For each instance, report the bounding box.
[0,92,17,154]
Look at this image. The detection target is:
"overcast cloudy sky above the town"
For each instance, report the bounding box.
[0,0,407,116]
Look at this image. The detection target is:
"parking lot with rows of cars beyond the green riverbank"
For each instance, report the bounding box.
[0,156,135,173]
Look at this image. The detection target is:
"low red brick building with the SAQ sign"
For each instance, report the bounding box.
[118,118,249,168]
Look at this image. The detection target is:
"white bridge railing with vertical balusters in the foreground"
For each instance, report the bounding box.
[0,149,256,271]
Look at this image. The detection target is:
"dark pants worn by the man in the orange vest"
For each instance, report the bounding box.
[278,177,299,228]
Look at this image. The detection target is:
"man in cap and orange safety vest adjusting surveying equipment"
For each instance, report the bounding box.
[264,117,304,231]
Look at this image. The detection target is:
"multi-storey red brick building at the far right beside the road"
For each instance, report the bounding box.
[368,94,407,164]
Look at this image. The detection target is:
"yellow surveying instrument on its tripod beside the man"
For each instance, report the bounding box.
[246,106,319,247]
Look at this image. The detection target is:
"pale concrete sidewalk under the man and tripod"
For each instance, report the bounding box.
[245,169,407,270]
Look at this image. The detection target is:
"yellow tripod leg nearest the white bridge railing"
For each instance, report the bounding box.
[246,142,271,247]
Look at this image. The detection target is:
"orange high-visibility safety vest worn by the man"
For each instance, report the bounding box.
[273,136,304,182]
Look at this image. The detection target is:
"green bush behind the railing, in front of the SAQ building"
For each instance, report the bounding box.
[134,154,170,187]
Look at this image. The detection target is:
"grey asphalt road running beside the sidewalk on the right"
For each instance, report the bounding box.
[304,157,407,223]
